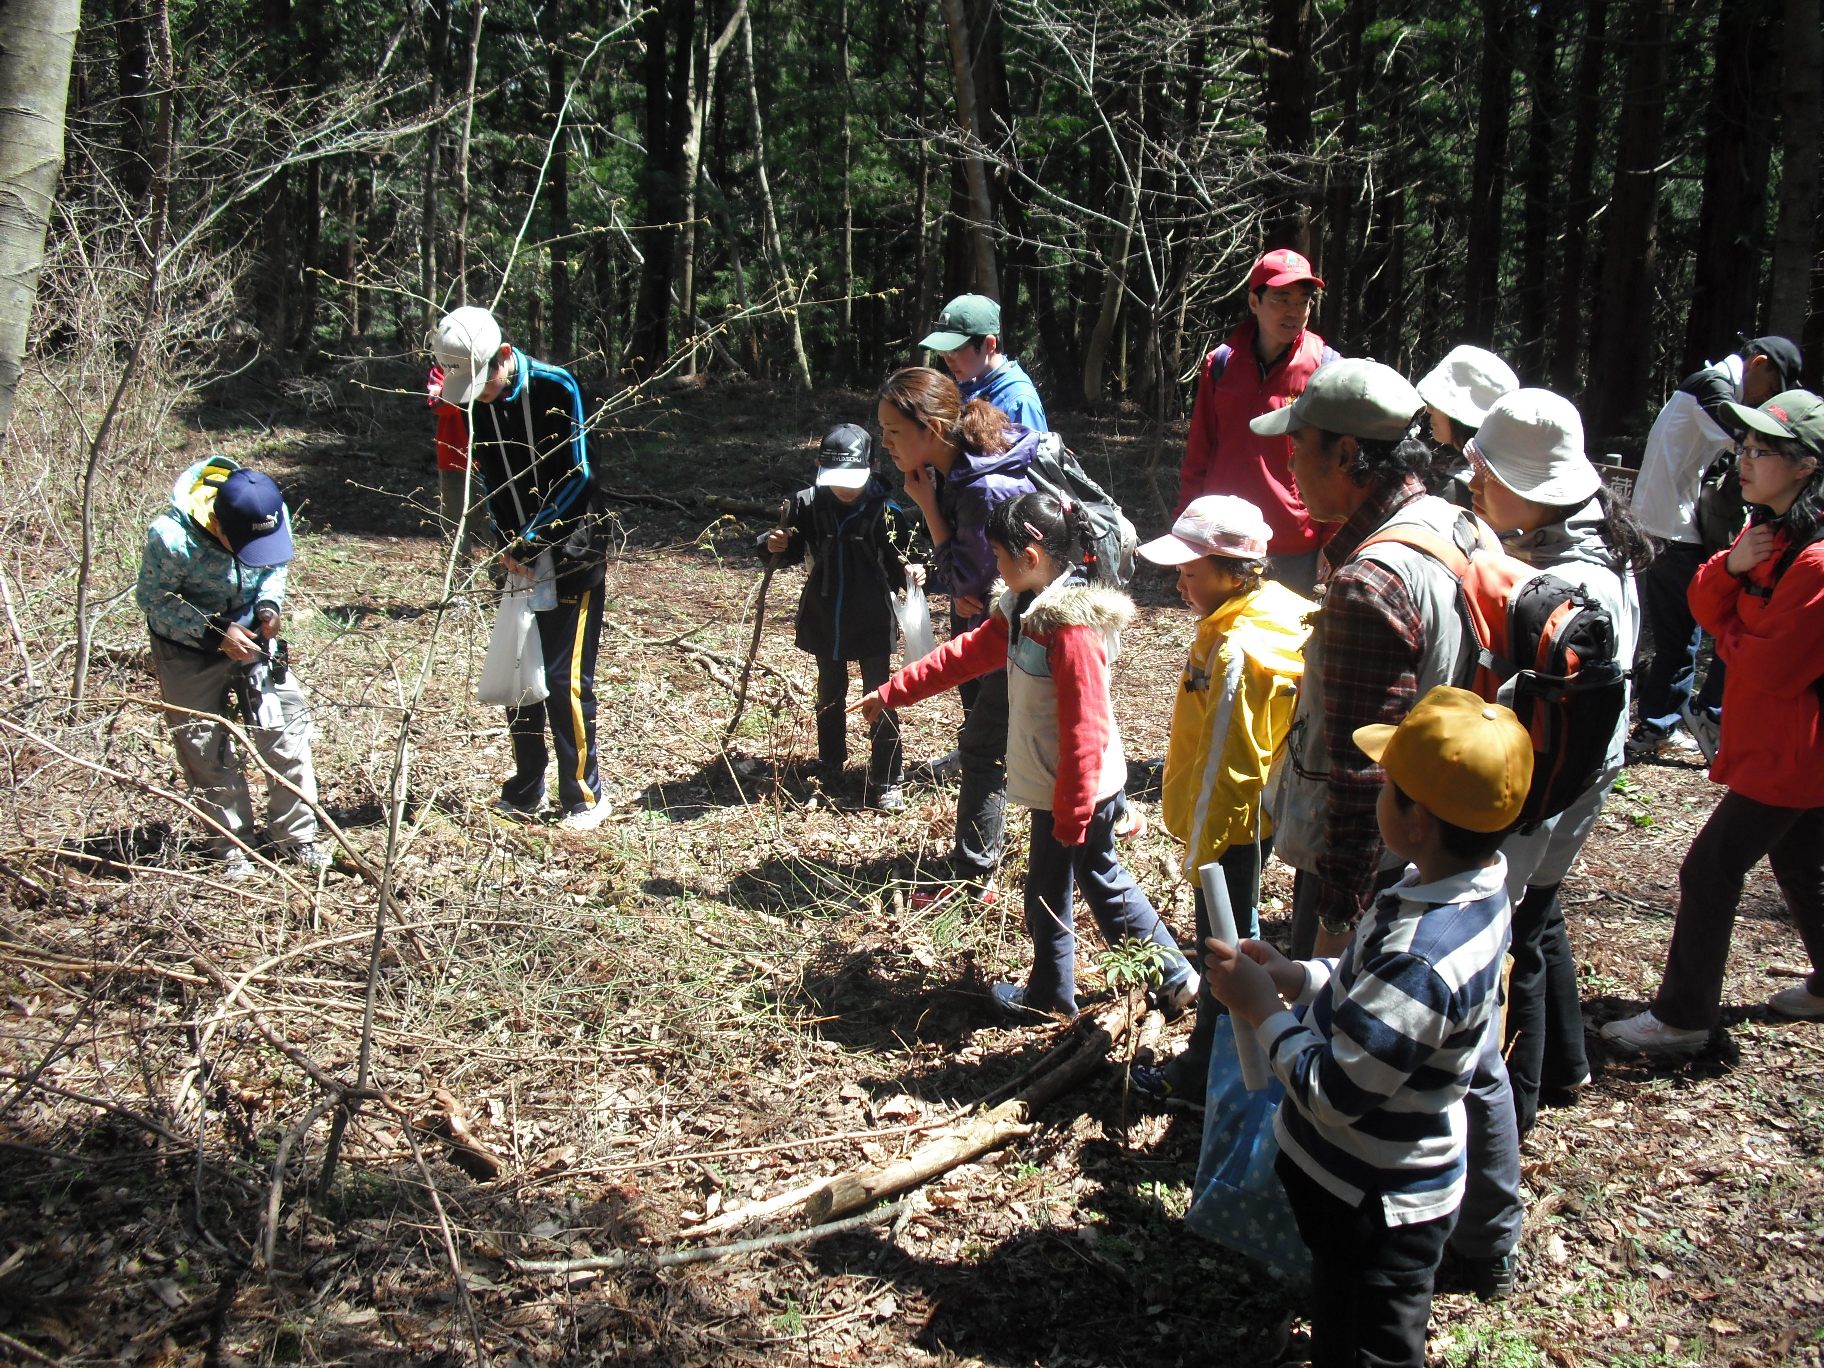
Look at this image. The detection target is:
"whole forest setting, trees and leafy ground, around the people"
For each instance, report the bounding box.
[0,0,1824,1368]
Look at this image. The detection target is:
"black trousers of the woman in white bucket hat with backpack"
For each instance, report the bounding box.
[1507,883,1591,1135]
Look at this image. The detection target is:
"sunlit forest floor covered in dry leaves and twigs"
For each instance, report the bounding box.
[0,366,1824,1368]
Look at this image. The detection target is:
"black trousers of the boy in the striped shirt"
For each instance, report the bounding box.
[1273,1155,1456,1368]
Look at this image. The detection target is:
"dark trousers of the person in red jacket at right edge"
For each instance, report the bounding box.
[1653,790,1824,1031]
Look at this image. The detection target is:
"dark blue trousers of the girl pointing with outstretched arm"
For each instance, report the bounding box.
[1021,791,1191,1014]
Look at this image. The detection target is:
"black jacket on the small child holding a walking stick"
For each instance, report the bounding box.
[779,476,912,660]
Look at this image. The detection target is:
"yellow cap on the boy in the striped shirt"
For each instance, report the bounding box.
[1355,684,1532,832]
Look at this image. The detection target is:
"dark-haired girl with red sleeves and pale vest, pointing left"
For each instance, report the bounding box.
[857,494,1197,1016]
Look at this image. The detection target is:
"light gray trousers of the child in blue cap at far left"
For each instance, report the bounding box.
[151,637,317,854]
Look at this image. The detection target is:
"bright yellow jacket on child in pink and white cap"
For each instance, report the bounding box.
[1160,580,1317,879]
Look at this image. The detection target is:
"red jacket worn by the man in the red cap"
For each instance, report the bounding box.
[1178,317,1335,556]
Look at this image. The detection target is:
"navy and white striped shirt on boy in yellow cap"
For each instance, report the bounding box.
[1259,855,1512,1226]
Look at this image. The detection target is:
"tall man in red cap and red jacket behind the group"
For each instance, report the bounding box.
[1178,248,1337,595]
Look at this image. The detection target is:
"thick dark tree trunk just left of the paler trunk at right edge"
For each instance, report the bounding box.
[1678,0,1780,374]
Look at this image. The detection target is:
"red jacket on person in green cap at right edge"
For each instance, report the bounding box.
[1687,536,1824,808]
